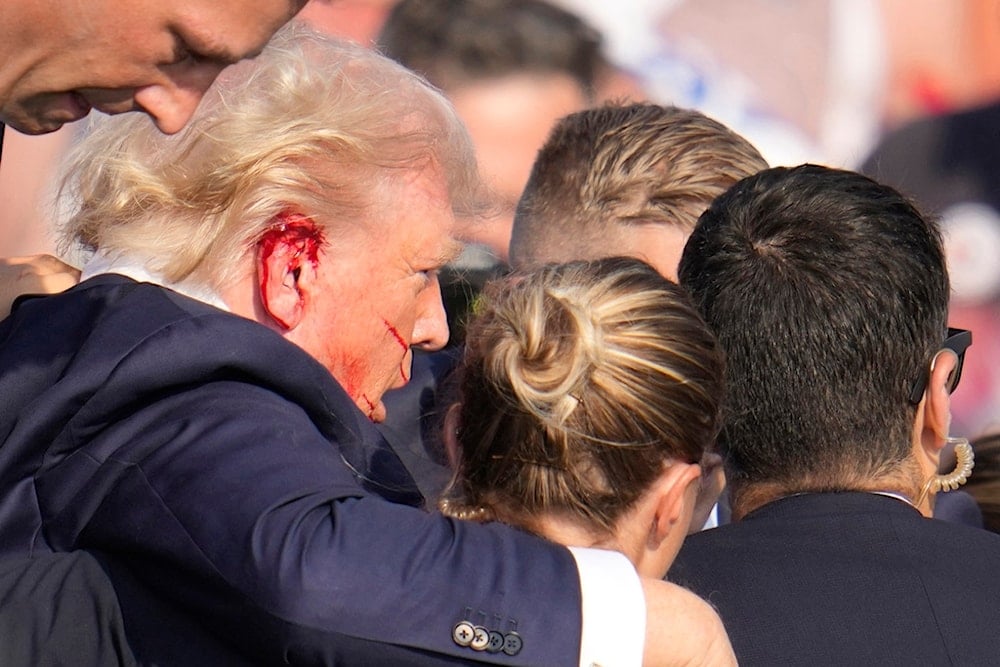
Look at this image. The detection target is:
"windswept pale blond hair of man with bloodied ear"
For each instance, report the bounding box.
[63,24,479,287]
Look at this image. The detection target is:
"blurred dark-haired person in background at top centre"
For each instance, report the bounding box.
[377,0,644,344]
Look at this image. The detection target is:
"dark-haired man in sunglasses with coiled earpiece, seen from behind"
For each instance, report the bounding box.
[671,165,1000,665]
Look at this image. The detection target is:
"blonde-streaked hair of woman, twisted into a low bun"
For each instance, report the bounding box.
[443,258,722,533]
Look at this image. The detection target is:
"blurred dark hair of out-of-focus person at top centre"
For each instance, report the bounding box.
[377,0,605,93]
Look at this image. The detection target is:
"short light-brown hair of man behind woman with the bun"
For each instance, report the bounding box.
[510,103,767,268]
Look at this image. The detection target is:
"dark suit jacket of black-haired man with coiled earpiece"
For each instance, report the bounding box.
[670,493,1000,667]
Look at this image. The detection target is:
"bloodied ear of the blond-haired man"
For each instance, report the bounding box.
[257,212,325,331]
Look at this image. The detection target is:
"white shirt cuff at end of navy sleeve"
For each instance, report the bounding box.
[569,547,646,667]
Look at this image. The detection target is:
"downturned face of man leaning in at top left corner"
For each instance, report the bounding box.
[0,0,304,134]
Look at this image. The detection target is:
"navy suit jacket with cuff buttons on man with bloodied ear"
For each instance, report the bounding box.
[0,275,580,665]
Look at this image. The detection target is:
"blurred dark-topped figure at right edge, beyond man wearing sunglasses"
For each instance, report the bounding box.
[861,95,1000,434]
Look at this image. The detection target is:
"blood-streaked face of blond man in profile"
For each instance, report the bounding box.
[300,167,459,421]
